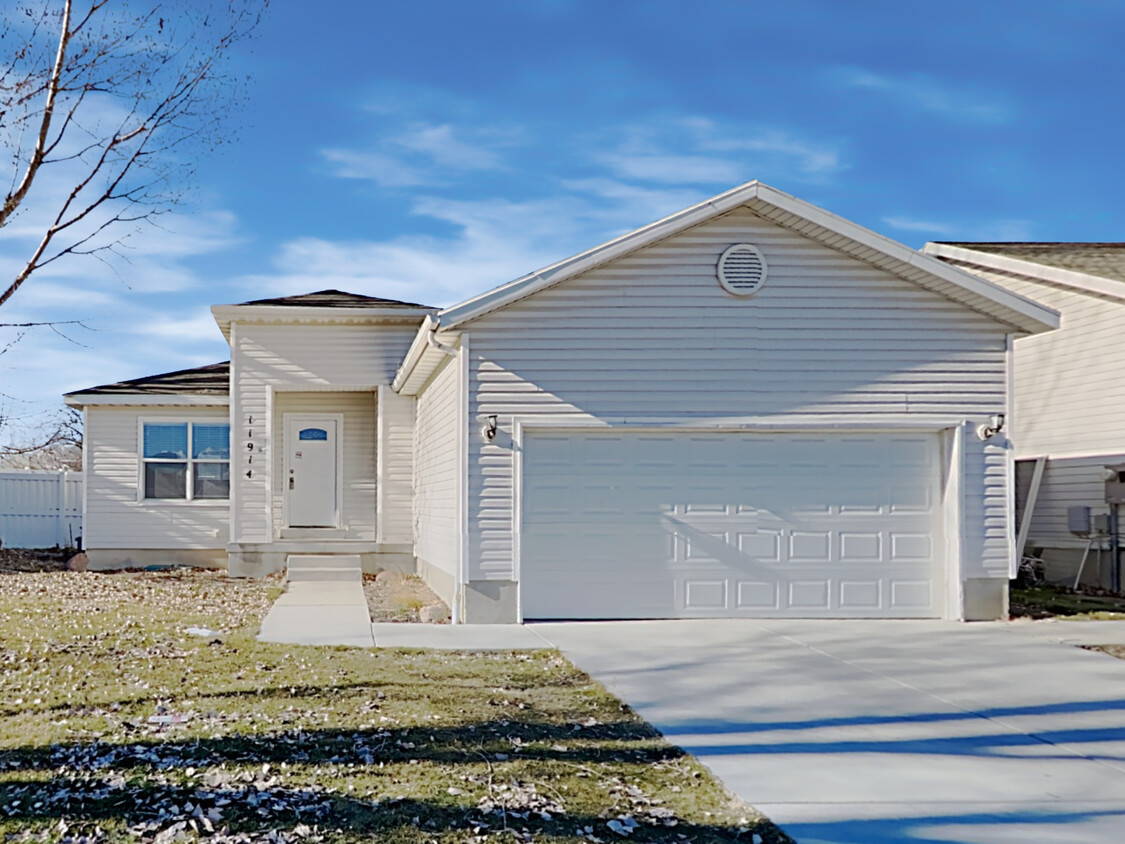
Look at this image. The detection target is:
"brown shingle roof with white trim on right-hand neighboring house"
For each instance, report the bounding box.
[923,242,1125,302]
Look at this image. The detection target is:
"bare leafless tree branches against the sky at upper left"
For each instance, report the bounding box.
[0,0,270,306]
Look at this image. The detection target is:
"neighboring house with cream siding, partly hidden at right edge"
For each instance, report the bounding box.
[924,243,1125,586]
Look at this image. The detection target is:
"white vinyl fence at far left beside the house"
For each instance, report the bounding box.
[0,470,82,548]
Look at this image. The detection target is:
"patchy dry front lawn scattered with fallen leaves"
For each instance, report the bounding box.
[0,572,786,844]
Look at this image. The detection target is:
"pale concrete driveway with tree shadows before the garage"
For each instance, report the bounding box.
[533,620,1125,844]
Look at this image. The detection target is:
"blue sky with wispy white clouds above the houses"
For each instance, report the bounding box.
[0,0,1125,438]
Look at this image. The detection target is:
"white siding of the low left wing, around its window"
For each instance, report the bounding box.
[82,407,230,549]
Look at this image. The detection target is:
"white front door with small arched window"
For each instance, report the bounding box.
[282,415,340,528]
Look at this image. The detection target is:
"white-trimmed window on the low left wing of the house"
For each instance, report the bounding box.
[141,422,231,501]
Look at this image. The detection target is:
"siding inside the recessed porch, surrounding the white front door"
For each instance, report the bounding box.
[271,392,376,542]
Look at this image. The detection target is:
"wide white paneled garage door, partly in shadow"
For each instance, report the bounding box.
[520,432,944,619]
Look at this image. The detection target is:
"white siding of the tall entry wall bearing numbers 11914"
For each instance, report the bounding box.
[231,321,417,542]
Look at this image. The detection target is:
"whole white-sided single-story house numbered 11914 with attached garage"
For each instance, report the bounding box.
[66,182,1058,622]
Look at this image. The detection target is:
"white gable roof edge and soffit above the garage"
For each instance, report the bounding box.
[437,181,1059,333]
